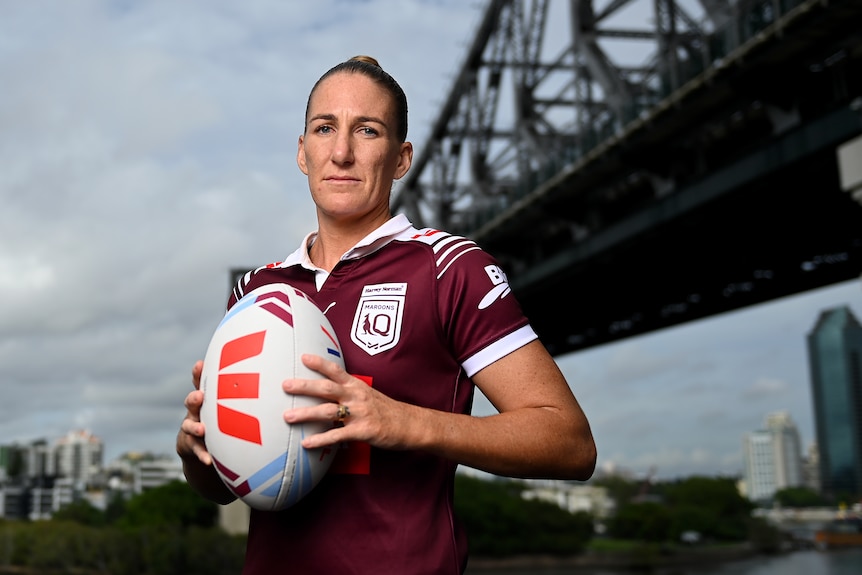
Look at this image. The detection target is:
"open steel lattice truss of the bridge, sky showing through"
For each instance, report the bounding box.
[393,0,726,233]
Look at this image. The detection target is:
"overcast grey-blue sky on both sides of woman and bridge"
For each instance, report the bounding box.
[0,0,862,484]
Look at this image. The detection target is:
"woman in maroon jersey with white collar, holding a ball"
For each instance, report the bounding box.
[177,57,596,574]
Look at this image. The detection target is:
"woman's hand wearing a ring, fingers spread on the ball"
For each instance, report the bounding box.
[282,354,419,449]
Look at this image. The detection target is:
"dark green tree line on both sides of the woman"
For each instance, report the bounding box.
[0,474,788,575]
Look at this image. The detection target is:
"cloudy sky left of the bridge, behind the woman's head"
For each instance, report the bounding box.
[0,0,482,464]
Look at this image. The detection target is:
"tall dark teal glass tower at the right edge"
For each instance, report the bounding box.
[808,306,862,495]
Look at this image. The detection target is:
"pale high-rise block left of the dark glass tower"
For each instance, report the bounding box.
[743,412,802,501]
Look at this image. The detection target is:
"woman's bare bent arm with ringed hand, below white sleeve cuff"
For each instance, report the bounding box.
[282,343,596,480]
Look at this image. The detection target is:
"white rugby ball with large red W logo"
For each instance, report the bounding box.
[200,284,344,511]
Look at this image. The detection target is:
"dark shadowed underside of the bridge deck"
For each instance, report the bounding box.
[513,138,862,355]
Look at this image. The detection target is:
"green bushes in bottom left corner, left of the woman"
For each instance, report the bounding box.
[0,481,245,575]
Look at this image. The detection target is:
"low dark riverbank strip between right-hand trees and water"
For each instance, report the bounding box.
[467,544,758,574]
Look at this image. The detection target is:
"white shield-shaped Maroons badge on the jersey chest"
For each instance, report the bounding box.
[350,283,407,355]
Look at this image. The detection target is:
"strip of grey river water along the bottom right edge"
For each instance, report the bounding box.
[467,548,862,575]
